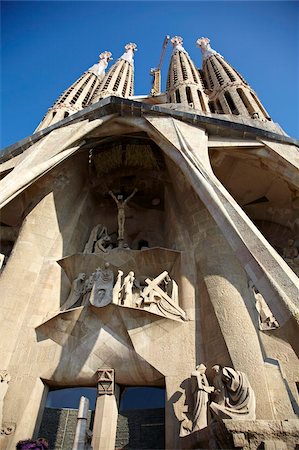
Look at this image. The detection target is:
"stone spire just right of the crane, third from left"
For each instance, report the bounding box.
[166,36,209,112]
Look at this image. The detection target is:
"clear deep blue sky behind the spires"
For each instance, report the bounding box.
[1,0,299,147]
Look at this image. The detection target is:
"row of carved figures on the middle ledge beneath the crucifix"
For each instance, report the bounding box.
[62,262,186,320]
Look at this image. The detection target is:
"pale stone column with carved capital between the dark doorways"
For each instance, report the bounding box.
[92,369,119,450]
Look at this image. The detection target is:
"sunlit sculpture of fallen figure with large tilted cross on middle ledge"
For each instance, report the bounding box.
[137,270,186,320]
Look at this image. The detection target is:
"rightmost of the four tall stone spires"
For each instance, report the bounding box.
[196,37,271,120]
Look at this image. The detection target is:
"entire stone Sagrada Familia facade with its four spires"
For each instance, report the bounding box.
[0,36,299,450]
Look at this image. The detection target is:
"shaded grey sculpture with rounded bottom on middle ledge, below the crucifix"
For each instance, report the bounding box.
[89,262,114,307]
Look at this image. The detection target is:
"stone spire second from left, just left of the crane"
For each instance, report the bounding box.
[92,42,137,103]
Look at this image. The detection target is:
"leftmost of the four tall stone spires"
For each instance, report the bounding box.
[35,51,112,131]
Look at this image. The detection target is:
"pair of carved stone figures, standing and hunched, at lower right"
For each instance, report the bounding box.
[180,364,255,437]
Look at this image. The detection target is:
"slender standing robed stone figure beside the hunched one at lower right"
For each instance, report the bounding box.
[191,364,215,431]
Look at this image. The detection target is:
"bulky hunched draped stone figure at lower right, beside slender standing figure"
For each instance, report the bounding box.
[210,365,255,420]
